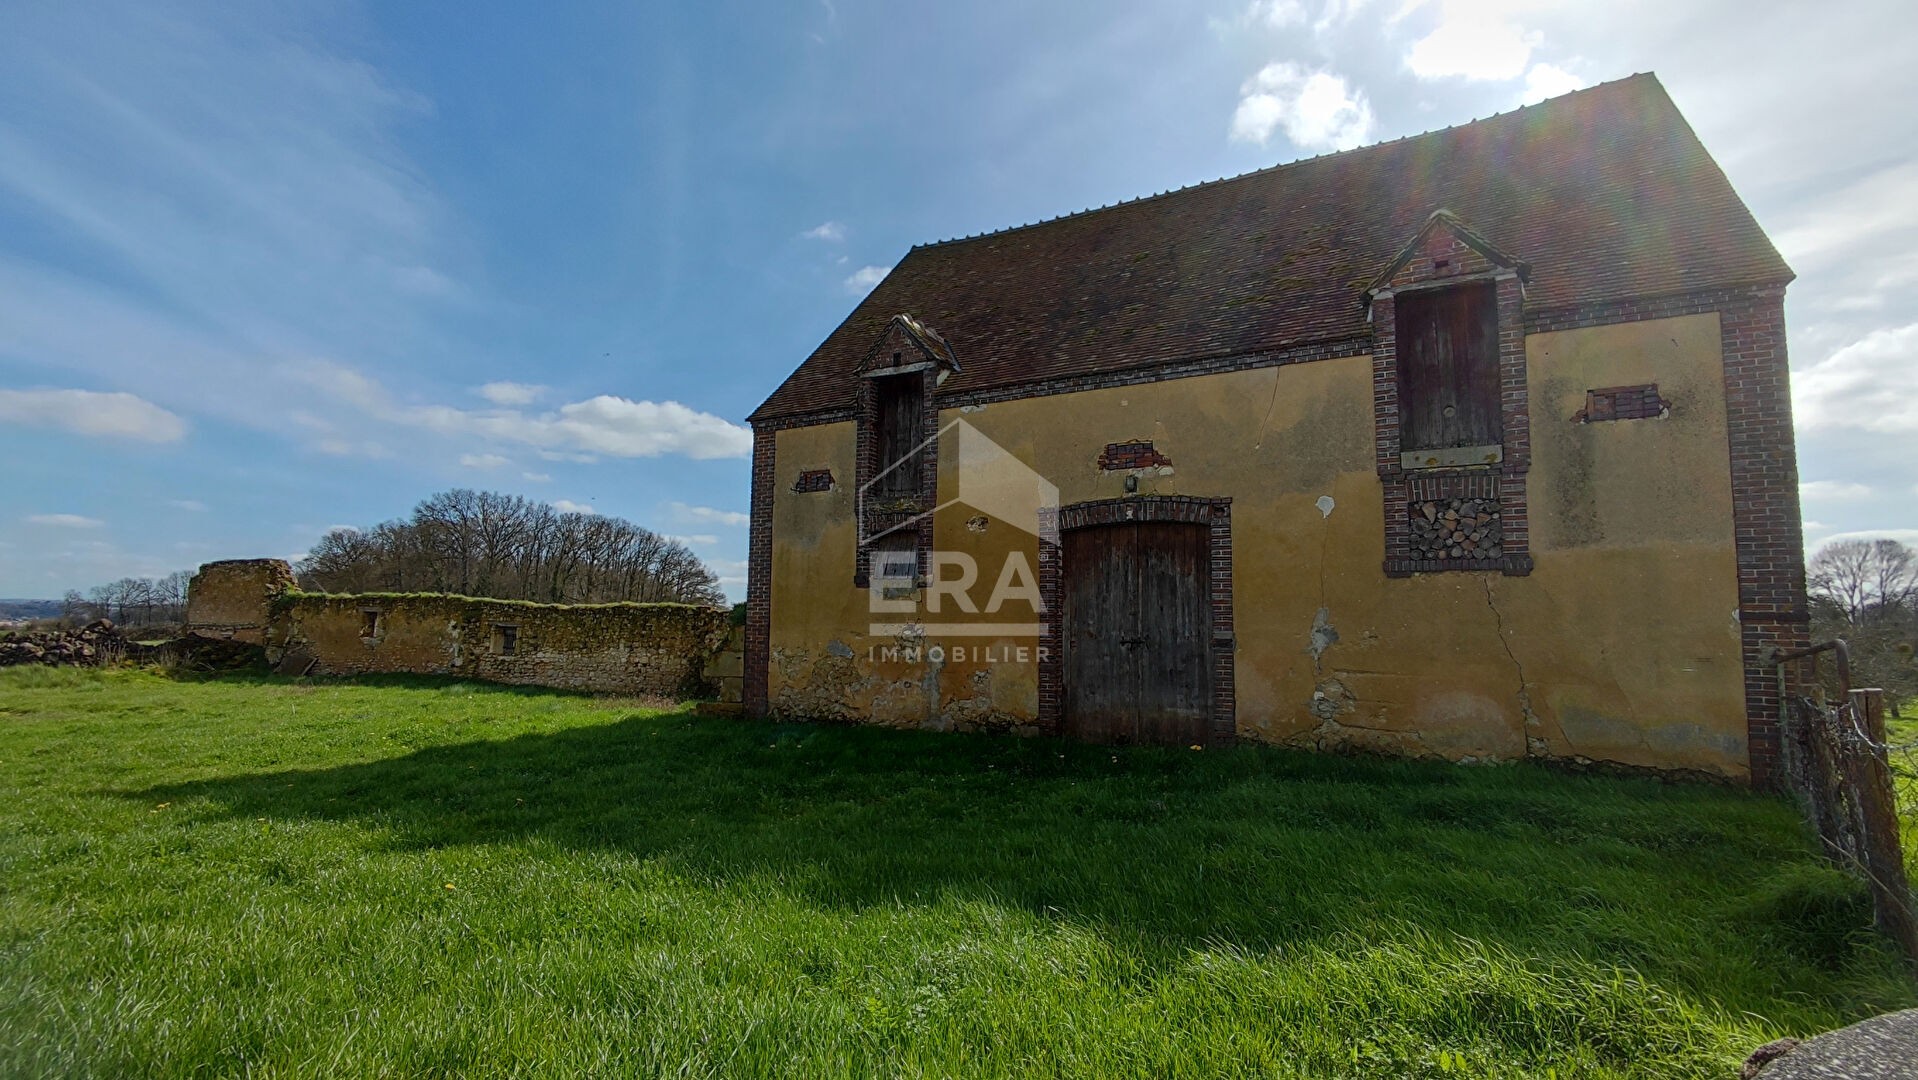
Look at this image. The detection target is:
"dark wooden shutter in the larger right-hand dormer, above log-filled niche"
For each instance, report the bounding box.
[1396,286,1504,451]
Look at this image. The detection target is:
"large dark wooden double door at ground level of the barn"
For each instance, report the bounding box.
[1063,522,1212,744]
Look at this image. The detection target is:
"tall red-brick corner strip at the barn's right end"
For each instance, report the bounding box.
[1719,288,1811,787]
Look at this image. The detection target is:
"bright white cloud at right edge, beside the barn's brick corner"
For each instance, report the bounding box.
[1791,322,1918,435]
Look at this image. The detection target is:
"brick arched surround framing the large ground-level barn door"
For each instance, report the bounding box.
[1040,495,1237,744]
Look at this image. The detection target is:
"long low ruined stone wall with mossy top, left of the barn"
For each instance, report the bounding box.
[278,593,727,696]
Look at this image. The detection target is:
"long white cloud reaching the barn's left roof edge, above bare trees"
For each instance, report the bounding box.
[290,361,752,462]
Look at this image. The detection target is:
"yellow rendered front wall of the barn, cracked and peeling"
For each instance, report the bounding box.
[769,315,1745,775]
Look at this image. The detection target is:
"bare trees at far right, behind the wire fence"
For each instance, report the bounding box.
[1805,539,1918,708]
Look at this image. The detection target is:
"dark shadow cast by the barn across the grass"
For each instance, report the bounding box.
[127,675,1882,1007]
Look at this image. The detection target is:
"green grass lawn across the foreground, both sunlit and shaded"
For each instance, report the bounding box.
[0,668,1914,1078]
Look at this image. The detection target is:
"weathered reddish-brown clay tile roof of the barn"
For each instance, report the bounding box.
[752,75,1791,420]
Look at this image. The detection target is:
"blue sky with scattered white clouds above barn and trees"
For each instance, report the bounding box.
[0,0,1918,597]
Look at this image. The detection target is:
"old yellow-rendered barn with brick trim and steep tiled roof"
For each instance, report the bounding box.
[744,75,1805,781]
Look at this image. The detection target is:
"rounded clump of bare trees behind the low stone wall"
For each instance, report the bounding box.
[293,487,725,604]
